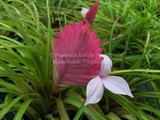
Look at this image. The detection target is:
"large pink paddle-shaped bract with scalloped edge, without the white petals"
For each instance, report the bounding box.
[52,20,103,85]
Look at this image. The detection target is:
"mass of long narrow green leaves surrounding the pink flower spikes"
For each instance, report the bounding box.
[0,0,160,120]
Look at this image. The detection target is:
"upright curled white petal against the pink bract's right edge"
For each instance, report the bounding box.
[99,54,112,78]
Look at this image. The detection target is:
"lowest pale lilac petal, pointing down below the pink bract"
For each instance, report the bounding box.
[84,76,104,105]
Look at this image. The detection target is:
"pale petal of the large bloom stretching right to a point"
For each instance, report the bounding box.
[102,76,134,98]
